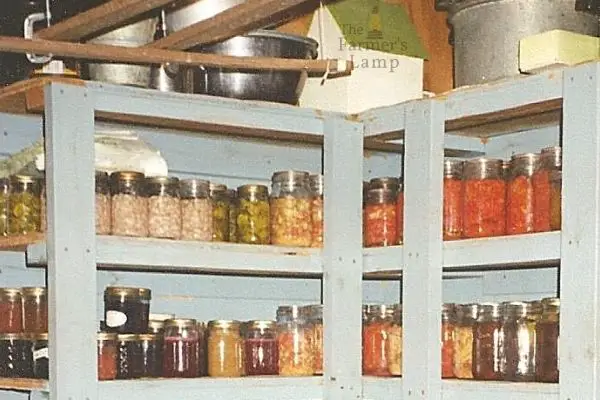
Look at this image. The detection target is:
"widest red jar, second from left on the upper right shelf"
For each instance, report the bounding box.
[463,158,506,238]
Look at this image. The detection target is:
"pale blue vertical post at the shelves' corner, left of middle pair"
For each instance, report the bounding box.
[323,118,363,400]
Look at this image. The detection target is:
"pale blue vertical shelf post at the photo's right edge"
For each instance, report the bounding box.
[559,63,600,400]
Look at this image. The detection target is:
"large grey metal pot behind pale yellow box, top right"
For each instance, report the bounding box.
[436,0,599,87]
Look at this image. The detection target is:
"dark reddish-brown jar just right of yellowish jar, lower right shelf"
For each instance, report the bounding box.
[473,303,503,380]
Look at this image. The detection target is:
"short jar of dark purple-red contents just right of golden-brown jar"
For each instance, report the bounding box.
[244,321,279,375]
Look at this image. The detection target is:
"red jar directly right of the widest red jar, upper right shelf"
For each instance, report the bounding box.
[506,153,539,235]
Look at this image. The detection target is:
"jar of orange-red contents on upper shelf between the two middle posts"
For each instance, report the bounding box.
[363,189,398,247]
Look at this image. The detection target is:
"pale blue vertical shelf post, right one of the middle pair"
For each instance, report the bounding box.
[402,100,445,400]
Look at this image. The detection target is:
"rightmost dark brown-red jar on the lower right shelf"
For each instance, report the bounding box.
[535,298,560,383]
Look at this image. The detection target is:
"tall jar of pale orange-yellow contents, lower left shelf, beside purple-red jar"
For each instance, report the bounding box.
[277,306,315,376]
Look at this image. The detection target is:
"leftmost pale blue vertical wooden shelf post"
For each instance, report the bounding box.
[45,83,97,400]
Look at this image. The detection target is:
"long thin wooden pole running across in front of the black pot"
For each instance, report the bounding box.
[0,36,353,78]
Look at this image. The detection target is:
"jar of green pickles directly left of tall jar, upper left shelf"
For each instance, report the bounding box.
[236,185,271,244]
